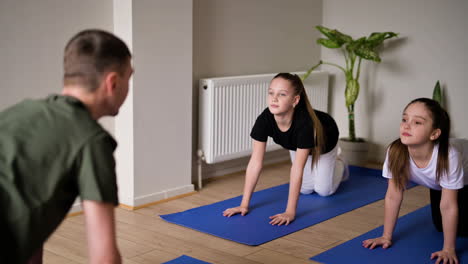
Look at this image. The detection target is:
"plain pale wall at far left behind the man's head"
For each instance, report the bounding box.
[0,0,112,130]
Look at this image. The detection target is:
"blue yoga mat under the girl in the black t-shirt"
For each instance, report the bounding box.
[161,166,416,246]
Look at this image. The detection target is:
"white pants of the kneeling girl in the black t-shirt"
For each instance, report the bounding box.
[289,146,349,196]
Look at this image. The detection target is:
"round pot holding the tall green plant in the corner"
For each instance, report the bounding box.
[338,138,370,166]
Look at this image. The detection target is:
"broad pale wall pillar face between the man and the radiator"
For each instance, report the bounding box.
[133,0,193,204]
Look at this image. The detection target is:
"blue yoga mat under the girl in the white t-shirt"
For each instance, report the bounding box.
[311,205,468,264]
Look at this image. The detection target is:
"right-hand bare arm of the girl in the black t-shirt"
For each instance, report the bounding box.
[270,149,310,225]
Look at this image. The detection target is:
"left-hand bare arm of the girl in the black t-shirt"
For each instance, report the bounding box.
[223,140,266,217]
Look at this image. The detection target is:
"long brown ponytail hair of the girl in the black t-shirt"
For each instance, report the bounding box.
[273,72,325,165]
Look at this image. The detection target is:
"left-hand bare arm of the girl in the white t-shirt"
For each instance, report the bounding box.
[362,179,403,249]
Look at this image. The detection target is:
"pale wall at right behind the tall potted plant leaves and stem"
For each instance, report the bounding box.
[322,0,468,161]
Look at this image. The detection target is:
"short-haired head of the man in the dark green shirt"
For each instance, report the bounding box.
[63,30,133,117]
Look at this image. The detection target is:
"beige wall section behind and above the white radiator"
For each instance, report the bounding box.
[192,0,322,177]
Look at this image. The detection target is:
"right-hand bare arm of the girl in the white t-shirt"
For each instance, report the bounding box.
[431,188,458,263]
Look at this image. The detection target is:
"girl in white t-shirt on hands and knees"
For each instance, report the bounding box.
[362,98,468,263]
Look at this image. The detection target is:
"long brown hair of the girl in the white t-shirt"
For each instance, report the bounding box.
[388,98,450,190]
